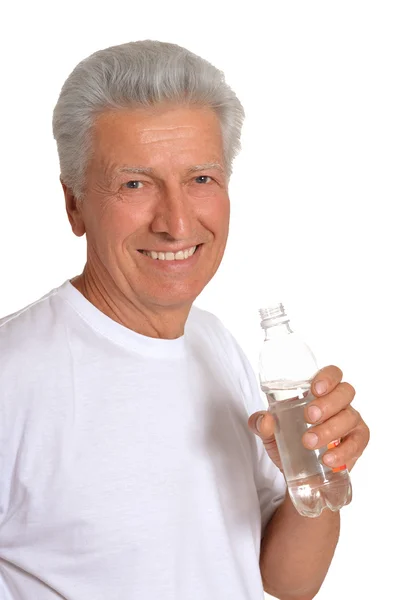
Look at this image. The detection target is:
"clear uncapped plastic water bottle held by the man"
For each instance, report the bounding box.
[259,304,352,517]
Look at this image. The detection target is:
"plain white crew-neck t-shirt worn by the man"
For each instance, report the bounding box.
[0,281,286,600]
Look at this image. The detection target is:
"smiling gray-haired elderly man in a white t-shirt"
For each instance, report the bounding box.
[0,41,369,600]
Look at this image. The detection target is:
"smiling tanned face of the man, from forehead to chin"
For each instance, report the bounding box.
[70,105,229,308]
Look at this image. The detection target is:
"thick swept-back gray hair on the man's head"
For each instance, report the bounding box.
[53,40,244,200]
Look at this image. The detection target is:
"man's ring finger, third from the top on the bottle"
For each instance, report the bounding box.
[302,406,361,450]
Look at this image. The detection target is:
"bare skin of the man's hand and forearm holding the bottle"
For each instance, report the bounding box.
[248,365,370,600]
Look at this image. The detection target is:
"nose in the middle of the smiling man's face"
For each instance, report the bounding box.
[151,185,195,240]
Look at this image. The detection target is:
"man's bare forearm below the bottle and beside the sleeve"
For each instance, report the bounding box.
[260,494,340,600]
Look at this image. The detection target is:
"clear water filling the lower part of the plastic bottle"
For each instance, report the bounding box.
[262,382,352,517]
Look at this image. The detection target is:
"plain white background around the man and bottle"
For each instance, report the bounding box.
[0,0,399,600]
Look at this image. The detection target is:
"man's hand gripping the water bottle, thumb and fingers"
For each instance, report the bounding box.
[248,366,370,471]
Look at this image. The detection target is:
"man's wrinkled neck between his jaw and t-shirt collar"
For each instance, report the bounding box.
[71,264,190,340]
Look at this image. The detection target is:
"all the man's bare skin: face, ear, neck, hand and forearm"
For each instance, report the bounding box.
[62,105,369,600]
